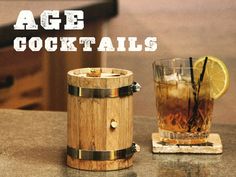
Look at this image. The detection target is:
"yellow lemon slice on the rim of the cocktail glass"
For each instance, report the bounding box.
[194,56,229,99]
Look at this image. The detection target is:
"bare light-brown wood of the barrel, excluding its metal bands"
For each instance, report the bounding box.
[67,68,133,171]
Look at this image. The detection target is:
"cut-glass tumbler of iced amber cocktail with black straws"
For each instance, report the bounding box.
[153,58,213,144]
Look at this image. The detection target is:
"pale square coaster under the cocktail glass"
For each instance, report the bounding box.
[152,133,223,154]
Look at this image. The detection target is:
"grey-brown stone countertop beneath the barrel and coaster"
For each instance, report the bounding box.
[0,110,236,177]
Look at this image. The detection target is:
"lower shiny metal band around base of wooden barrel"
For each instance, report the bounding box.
[67,143,137,161]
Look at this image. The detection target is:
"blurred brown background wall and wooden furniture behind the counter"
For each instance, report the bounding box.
[0,0,236,124]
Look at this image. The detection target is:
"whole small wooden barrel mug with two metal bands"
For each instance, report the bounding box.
[67,68,140,171]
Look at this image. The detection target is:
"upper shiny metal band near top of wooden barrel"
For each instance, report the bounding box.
[68,82,141,98]
